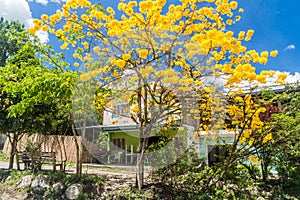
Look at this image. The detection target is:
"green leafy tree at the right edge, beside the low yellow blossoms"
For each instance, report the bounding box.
[265,85,300,189]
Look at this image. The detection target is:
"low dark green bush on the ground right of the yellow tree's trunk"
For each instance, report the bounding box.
[151,151,268,199]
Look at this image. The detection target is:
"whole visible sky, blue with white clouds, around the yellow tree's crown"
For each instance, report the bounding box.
[0,0,300,78]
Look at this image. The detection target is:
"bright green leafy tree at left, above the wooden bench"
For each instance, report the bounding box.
[0,44,75,168]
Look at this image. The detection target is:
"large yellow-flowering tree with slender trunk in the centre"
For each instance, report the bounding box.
[29,0,284,188]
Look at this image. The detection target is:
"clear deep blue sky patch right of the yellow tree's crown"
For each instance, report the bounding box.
[235,0,300,72]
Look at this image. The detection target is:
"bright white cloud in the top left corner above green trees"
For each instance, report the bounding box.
[0,0,49,43]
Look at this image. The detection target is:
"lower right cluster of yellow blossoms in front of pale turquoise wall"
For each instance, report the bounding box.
[226,94,273,163]
